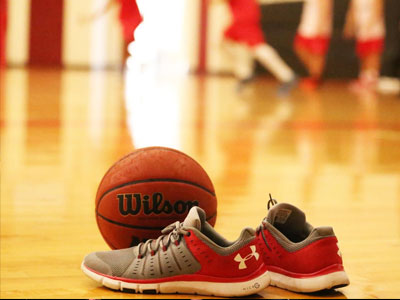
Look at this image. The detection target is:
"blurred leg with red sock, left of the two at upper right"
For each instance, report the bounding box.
[294,0,333,90]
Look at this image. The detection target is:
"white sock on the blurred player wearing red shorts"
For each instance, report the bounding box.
[253,44,295,82]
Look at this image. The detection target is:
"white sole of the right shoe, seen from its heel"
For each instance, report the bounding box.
[269,271,350,293]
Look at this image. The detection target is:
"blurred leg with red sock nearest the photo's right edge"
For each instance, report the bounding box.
[345,0,385,92]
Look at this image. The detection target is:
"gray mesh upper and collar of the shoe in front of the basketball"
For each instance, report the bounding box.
[84,207,255,280]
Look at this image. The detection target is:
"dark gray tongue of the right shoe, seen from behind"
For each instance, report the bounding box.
[267,203,307,235]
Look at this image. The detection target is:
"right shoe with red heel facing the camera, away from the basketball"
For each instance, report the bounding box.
[257,198,349,293]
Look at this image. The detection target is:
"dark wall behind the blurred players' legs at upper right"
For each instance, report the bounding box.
[257,0,400,78]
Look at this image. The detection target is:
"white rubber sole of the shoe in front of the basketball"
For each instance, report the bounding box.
[81,263,270,297]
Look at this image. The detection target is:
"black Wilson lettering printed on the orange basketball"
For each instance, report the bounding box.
[117,193,199,216]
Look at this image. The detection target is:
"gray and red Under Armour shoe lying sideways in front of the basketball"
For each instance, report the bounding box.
[81,207,270,297]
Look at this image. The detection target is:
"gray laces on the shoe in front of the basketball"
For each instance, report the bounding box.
[134,221,190,258]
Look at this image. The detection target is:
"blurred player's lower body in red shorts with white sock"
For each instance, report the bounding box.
[224,0,297,94]
